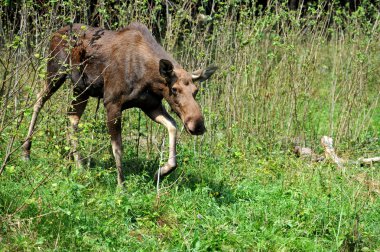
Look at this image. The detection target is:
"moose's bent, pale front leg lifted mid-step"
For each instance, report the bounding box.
[144,105,177,181]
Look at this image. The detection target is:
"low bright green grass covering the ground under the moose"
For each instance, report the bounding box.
[0,122,380,251]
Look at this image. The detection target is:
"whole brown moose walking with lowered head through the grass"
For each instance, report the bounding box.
[22,23,217,186]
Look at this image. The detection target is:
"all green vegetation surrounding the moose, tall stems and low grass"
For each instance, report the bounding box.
[0,0,380,251]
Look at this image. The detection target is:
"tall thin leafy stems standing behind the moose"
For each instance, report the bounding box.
[1,2,380,159]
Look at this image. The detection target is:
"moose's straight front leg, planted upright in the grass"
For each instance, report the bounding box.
[106,104,124,187]
